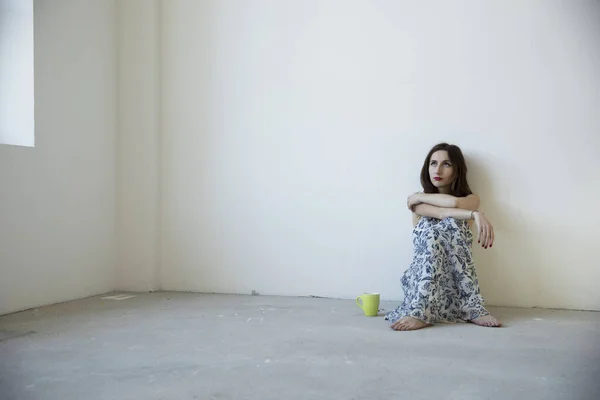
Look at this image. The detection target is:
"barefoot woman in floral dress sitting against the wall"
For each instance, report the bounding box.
[386,143,502,331]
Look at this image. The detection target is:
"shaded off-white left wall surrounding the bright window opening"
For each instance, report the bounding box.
[0,0,116,314]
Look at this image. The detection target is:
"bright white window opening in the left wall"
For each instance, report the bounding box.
[0,0,34,146]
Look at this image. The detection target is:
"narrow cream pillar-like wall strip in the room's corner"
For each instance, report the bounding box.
[116,0,161,291]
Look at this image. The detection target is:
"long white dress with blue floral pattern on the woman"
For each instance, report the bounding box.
[386,217,489,324]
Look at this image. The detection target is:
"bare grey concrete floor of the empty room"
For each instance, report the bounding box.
[0,293,600,400]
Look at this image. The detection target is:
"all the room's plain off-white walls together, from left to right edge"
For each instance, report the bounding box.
[0,0,600,314]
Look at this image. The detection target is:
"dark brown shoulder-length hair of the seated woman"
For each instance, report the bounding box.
[421,143,473,197]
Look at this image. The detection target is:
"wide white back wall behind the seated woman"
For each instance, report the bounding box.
[161,0,600,310]
